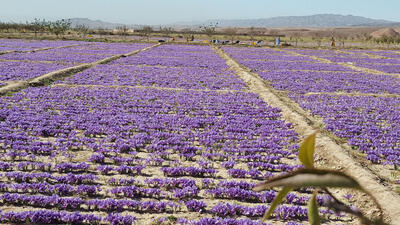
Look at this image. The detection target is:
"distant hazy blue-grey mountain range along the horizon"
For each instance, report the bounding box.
[70,14,400,29]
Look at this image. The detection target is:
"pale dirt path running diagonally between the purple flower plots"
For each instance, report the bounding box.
[213,46,400,224]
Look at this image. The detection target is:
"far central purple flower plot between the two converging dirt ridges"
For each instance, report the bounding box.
[62,45,245,90]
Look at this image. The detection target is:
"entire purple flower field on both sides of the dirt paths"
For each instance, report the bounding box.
[0,40,400,225]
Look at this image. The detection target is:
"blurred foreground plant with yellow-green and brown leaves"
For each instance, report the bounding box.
[253,132,386,225]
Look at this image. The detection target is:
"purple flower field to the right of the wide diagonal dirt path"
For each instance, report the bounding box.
[224,47,400,183]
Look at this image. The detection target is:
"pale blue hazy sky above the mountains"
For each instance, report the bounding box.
[0,0,400,25]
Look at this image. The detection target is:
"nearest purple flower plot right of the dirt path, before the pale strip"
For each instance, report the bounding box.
[292,95,400,166]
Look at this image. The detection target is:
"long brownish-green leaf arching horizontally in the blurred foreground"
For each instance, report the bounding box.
[253,168,362,191]
